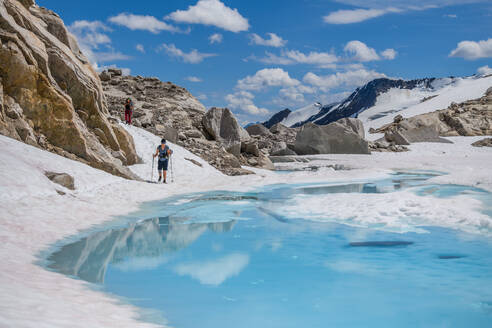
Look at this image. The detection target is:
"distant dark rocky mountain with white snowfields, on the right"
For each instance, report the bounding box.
[264,76,492,128]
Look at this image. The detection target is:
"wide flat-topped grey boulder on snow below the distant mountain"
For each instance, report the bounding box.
[294,121,370,155]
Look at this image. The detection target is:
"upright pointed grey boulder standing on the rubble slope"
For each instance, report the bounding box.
[202,107,250,156]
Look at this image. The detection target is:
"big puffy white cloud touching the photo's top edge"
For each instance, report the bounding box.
[167,0,249,33]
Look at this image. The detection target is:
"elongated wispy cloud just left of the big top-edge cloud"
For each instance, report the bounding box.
[108,13,180,34]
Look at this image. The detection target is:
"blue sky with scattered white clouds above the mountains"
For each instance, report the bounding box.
[37,0,492,122]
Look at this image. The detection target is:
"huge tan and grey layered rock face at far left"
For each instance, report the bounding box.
[0,0,140,178]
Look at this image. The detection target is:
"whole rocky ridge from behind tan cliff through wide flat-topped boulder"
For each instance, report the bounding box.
[100,69,378,165]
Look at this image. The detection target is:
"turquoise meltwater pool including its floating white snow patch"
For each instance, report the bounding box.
[47,173,492,328]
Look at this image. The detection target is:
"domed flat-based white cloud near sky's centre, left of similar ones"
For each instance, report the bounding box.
[237,68,300,91]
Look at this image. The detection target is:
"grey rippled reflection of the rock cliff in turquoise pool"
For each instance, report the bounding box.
[48,217,235,283]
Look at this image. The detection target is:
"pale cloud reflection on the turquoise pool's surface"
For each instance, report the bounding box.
[174,253,249,286]
